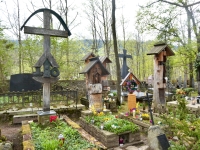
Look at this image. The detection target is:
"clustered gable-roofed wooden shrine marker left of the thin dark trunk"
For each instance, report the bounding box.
[80,53,111,110]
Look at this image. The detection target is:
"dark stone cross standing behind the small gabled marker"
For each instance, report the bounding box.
[118,49,132,79]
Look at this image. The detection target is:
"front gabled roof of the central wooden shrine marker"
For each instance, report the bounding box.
[79,57,110,76]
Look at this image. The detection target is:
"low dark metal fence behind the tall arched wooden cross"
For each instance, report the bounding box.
[0,89,78,109]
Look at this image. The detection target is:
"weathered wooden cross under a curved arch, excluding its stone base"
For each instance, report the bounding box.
[21,8,71,112]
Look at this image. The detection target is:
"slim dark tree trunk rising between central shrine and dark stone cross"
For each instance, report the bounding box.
[112,0,121,105]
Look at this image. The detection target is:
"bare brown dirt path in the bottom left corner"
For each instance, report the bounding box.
[0,122,23,150]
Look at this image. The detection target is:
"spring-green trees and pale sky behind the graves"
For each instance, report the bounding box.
[0,0,200,89]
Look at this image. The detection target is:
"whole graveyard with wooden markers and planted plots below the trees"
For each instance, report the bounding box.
[0,0,200,150]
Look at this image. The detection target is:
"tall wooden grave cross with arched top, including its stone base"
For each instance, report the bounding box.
[21,8,71,123]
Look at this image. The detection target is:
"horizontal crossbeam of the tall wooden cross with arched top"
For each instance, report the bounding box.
[24,26,68,38]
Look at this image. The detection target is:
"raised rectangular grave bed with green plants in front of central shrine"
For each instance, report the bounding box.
[79,112,140,148]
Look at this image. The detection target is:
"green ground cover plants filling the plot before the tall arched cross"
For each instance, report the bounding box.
[30,119,95,150]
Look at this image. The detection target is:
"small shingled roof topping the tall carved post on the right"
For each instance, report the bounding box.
[147,42,175,56]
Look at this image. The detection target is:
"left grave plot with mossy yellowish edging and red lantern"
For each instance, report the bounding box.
[22,117,98,150]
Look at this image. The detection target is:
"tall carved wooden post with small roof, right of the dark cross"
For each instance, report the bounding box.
[147,43,175,109]
